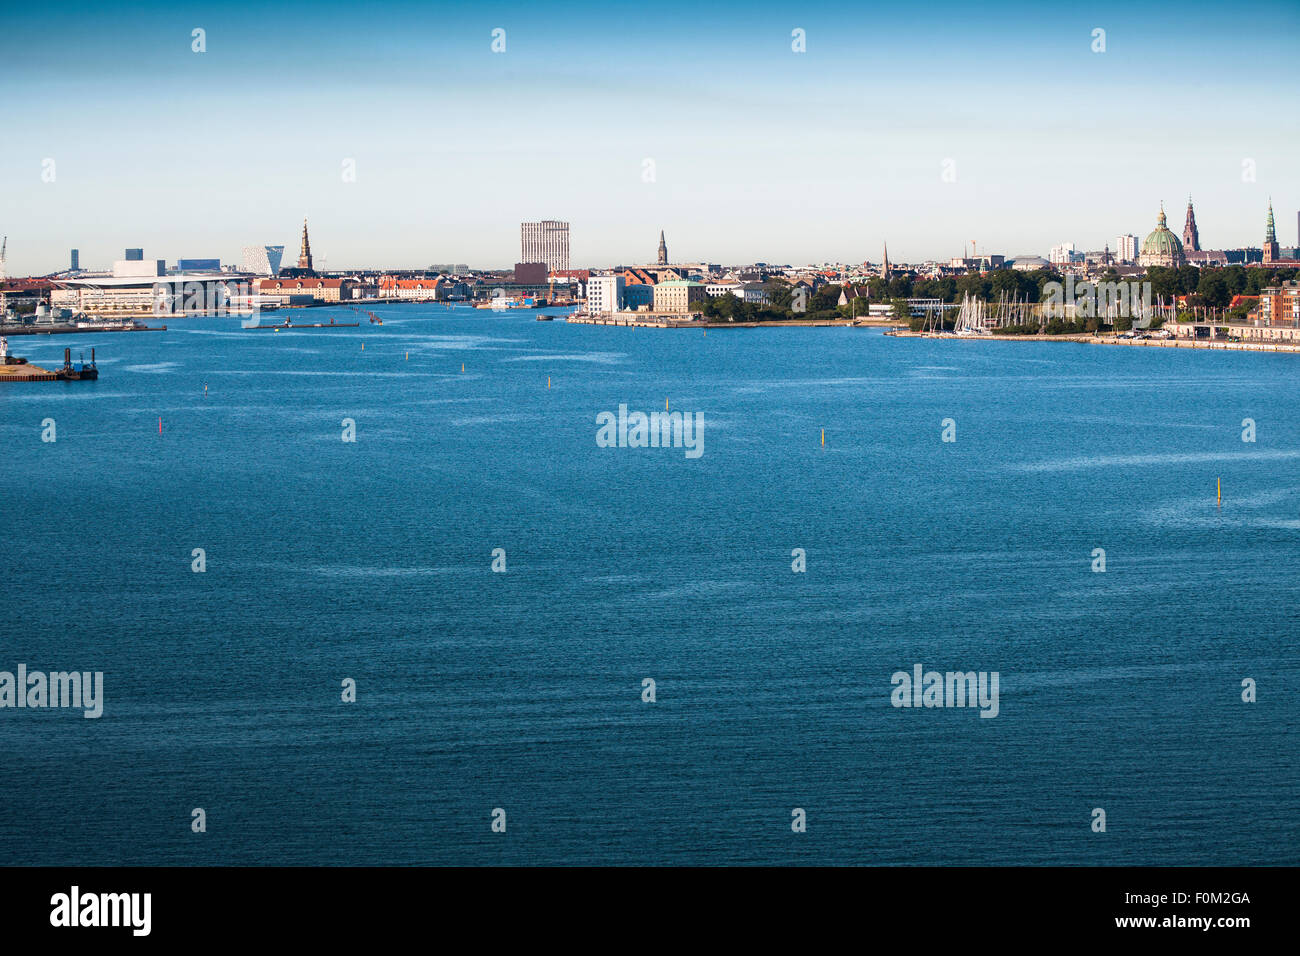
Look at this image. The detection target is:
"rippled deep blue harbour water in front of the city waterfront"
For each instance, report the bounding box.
[0,306,1300,865]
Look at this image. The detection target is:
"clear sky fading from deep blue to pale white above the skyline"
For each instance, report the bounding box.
[0,0,1300,276]
